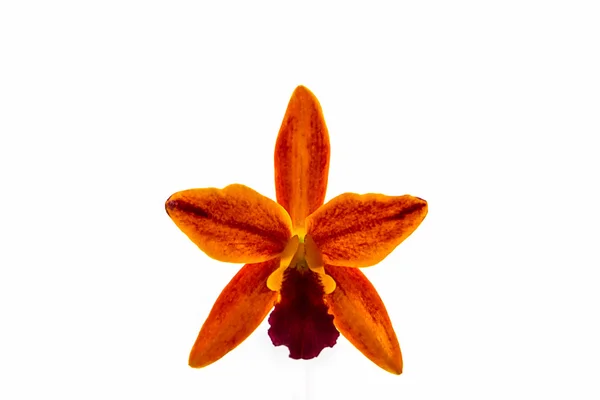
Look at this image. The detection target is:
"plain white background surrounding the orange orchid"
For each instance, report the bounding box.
[0,0,600,400]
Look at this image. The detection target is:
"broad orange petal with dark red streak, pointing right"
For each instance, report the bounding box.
[306,193,427,267]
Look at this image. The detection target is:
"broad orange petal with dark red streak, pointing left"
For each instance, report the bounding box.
[166,185,291,263]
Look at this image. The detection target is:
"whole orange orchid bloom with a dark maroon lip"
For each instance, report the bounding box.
[166,86,427,374]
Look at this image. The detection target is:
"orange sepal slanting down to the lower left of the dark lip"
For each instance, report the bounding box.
[189,258,279,368]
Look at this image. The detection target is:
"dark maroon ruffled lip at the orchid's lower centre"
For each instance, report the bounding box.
[269,267,340,360]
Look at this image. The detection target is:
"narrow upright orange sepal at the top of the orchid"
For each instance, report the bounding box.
[275,86,329,230]
